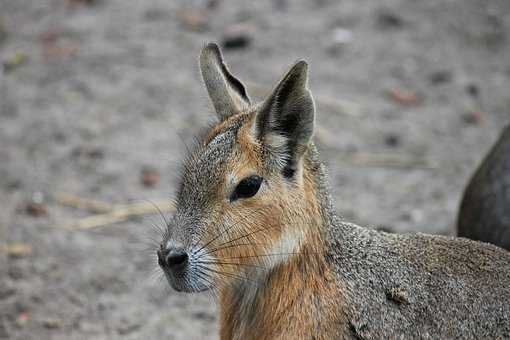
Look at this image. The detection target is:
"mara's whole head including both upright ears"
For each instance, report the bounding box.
[157,44,319,292]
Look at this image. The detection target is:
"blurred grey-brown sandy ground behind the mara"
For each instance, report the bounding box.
[0,0,510,339]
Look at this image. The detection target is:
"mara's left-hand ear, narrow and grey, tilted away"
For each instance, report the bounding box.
[199,43,250,120]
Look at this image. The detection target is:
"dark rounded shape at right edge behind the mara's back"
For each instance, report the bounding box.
[457,125,510,250]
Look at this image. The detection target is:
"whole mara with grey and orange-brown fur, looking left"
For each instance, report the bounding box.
[158,44,510,340]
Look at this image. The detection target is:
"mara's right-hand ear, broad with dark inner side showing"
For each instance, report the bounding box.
[254,60,315,178]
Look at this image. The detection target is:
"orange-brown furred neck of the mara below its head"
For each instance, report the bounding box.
[220,145,342,340]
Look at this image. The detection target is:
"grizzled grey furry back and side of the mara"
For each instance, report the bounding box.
[308,148,510,339]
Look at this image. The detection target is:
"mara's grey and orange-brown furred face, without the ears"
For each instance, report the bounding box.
[161,113,306,292]
